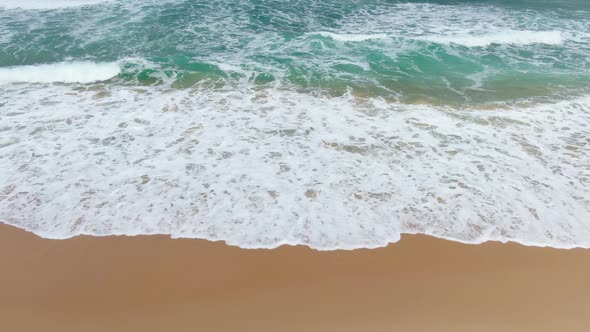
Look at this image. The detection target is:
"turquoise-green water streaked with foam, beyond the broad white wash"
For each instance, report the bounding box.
[0,0,590,103]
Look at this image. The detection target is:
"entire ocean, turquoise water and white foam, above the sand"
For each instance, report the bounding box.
[0,0,590,250]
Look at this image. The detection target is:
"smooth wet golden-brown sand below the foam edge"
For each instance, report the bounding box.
[0,225,590,332]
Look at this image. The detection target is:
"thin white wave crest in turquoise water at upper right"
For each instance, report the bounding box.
[417,30,564,47]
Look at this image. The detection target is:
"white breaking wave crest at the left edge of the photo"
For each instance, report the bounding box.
[0,62,121,84]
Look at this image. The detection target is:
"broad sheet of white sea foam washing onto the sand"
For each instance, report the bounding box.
[0,85,590,249]
